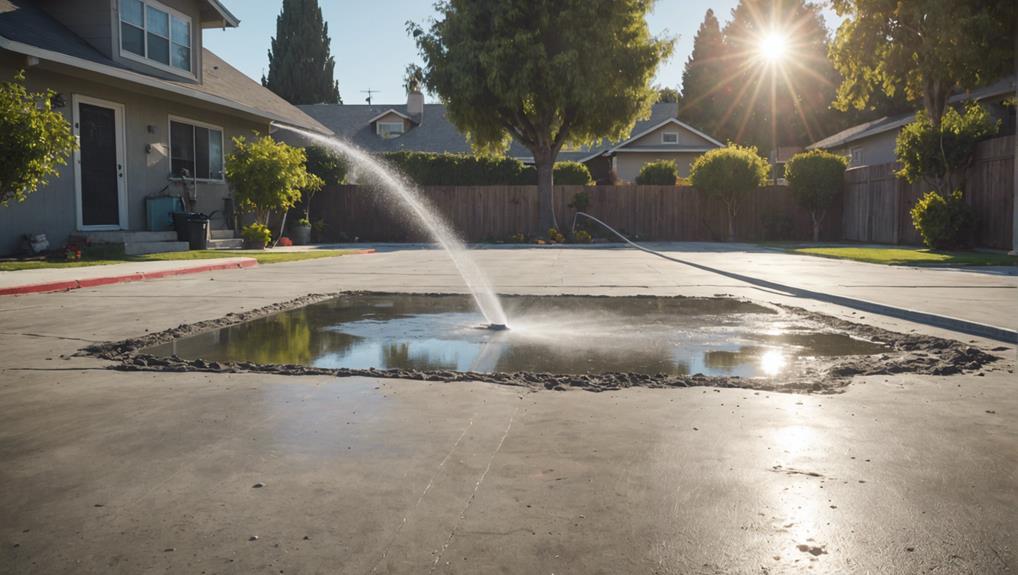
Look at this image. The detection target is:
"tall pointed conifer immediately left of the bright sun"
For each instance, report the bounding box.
[679,9,734,133]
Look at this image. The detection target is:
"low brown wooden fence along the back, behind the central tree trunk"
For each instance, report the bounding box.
[313,185,841,241]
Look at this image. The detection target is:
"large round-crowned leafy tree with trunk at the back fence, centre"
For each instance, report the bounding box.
[407,0,672,230]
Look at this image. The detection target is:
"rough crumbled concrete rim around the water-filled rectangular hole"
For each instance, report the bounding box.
[76,290,1008,394]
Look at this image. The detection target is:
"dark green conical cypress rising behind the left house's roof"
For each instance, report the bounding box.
[262,0,343,105]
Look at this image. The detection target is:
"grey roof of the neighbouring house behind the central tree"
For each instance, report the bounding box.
[299,103,721,162]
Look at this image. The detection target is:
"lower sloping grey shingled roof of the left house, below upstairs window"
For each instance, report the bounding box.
[0,0,331,133]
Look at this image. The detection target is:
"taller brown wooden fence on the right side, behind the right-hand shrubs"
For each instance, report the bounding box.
[841,135,1015,249]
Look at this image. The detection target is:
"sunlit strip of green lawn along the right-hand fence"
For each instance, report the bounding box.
[782,245,1018,266]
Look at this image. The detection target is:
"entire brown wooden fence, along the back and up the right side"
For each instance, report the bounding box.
[313,135,1015,249]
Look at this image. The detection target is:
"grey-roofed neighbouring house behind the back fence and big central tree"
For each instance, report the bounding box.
[295,94,722,181]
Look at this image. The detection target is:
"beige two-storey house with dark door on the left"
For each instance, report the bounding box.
[0,0,331,253]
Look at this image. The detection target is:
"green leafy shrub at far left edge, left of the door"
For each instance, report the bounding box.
[0,71,77,207]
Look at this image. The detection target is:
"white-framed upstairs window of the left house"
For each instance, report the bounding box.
[120,0,191,72]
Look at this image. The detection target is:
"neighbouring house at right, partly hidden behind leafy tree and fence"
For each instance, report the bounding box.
[806,77,1015,168]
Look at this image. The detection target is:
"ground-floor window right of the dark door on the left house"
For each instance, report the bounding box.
[170,119,223,182]
